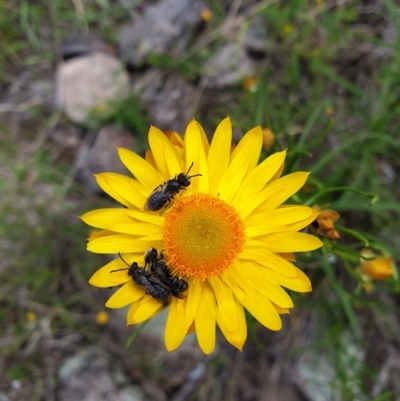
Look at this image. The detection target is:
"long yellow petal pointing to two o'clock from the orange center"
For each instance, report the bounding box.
[236,172,309,219]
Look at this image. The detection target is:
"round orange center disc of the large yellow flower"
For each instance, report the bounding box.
[163,194,245,279]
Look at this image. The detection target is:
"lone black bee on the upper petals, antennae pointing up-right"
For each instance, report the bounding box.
[144,163,201,212]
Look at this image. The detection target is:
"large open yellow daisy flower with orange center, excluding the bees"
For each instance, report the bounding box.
[82,118,322,354]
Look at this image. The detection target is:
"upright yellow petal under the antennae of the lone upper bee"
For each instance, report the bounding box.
[184,120,209,193]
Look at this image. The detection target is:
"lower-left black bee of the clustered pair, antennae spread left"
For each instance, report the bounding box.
[110,254,171,305]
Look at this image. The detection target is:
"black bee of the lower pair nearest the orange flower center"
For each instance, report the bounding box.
[144,248,189,299]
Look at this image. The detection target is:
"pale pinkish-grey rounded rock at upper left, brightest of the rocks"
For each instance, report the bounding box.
[56,53,130,122]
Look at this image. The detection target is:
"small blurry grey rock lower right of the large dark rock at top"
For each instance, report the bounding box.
[205,43,255,88]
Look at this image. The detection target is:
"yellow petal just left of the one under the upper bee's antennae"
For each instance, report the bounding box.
[149,127,184,176]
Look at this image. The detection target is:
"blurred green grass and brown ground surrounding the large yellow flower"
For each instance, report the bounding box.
[0,0,400,401]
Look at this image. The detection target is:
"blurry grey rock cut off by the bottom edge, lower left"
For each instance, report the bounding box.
[58,347,144,401]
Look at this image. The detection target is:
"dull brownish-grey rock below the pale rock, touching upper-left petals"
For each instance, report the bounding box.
[75,126,135,192]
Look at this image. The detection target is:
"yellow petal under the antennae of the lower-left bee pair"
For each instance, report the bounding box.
[89,253,143,288]
